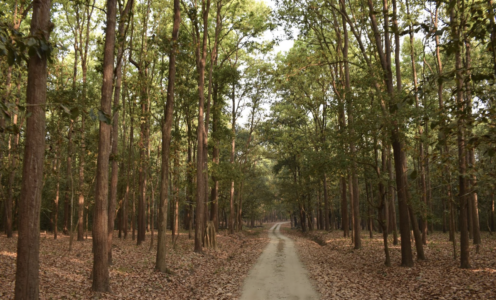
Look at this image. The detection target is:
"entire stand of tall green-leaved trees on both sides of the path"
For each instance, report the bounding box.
[0,0,496,299]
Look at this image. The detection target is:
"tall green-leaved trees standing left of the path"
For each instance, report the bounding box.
[0,0,273,299]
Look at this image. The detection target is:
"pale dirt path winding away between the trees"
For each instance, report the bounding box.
[241,223,319,300]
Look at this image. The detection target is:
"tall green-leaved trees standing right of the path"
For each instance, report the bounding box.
[269,0,495,268]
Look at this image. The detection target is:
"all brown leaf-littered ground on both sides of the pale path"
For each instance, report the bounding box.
[0,223,496,300]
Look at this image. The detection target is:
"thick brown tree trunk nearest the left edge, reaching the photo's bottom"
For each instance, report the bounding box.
[15,0,53,300]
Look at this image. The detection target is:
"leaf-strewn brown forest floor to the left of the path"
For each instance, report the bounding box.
[0,225,269,300]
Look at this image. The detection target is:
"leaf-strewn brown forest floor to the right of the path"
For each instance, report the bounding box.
[282,224,496,299]
